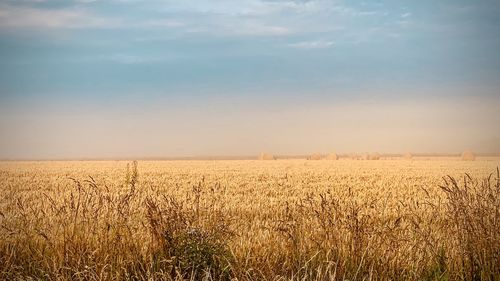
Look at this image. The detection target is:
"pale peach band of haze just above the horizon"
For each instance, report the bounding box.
[0,94,500,159]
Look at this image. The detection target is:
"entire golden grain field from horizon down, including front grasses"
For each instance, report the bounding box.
[0,160,500,280]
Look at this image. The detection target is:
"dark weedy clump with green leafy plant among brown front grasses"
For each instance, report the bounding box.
[146,178,232,280]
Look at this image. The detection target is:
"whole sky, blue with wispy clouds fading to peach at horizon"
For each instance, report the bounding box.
[0,0,500,159]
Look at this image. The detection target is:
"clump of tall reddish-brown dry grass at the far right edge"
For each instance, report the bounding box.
[441,168,500,280]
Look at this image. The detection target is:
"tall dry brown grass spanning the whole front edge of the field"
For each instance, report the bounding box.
[0,162,500,280]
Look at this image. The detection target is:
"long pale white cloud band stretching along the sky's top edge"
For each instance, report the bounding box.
[0,0,398,40]
